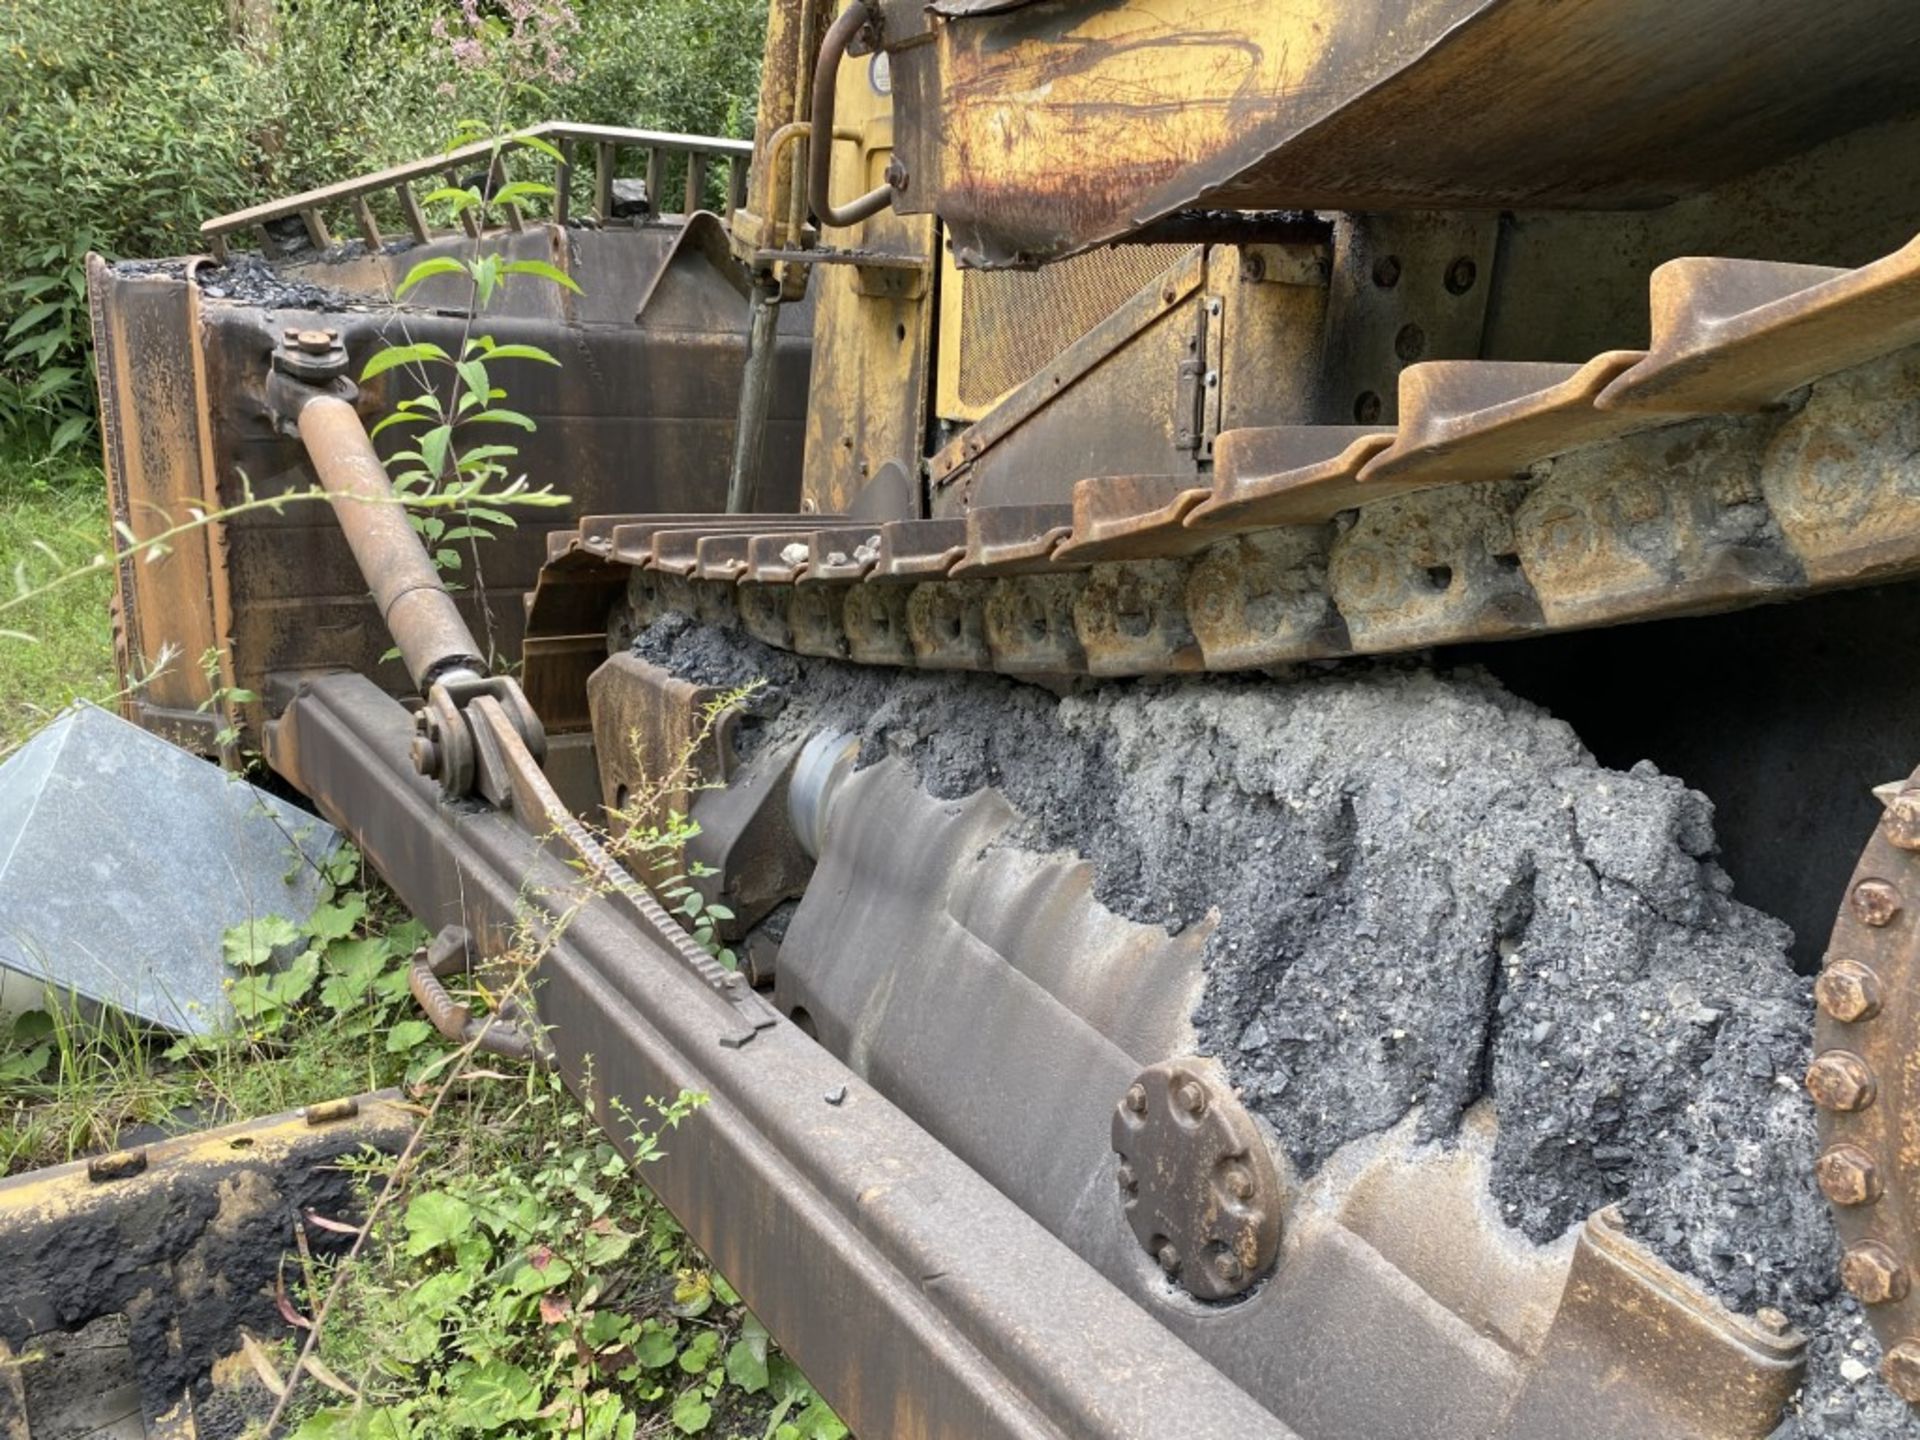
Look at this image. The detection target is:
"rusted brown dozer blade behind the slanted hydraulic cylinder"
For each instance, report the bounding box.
[92,227,810,749]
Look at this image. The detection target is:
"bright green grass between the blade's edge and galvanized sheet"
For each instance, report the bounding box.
[0,453,119,756]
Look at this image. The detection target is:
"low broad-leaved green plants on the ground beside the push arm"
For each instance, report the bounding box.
[286,1075,847,1440]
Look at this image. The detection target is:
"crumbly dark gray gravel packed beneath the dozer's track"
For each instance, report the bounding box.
[636,616,1920,1440]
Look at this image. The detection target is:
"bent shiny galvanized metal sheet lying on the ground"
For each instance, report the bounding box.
[0,705,340,1035]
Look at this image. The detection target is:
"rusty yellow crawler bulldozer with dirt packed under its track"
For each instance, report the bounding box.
[71,0,1920,1440]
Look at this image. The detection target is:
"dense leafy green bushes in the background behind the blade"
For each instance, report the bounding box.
[0,0,766,451]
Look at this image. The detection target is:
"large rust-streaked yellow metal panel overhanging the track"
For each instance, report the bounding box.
[893,0,1920,265]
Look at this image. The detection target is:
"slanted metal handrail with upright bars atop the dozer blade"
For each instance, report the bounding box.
[200,121,753,263]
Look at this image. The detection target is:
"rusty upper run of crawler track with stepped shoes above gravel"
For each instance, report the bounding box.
[530,240,1920,676]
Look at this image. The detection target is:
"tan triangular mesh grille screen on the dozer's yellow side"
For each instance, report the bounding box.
[958,246,1192,409]
